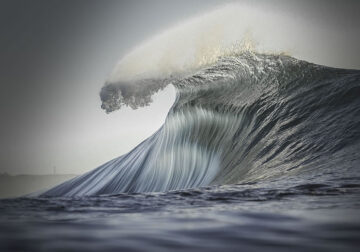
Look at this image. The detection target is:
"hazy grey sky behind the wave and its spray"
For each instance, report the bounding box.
[0,0,360,174]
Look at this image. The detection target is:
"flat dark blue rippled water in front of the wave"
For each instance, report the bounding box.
[0,173,360,251]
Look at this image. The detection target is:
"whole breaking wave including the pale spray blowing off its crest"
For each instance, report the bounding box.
[42,5,360,196]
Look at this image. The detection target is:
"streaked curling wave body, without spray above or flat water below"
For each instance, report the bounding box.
[43,52,360,196]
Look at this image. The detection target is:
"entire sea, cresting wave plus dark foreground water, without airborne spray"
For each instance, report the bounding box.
[0,52,360,251]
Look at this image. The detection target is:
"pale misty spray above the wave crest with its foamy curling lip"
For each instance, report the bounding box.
[100,4,352,113]
